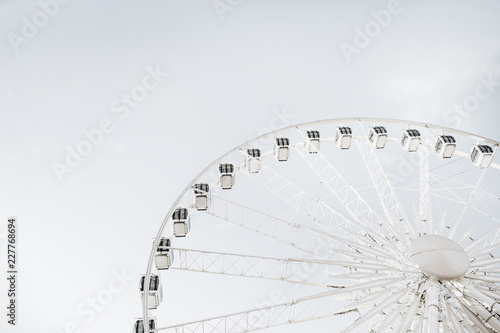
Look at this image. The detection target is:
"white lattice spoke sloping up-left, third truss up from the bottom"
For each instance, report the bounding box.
[203,194,333,258]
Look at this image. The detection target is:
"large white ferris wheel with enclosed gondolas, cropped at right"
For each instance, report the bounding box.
[134,118,500,333]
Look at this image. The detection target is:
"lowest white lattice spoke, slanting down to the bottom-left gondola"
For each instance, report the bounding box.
[156,292,356,333]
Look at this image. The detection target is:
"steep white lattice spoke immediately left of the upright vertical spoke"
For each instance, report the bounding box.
[355,127,417,238]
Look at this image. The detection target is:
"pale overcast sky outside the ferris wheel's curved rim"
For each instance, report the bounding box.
[0,0,500,333]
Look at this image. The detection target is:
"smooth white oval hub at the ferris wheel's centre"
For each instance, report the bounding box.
[409,235,469,280]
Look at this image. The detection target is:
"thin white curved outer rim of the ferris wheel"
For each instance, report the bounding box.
[142,117,500,333]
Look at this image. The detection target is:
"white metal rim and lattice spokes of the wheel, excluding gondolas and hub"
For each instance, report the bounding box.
[143,118,500,332]
